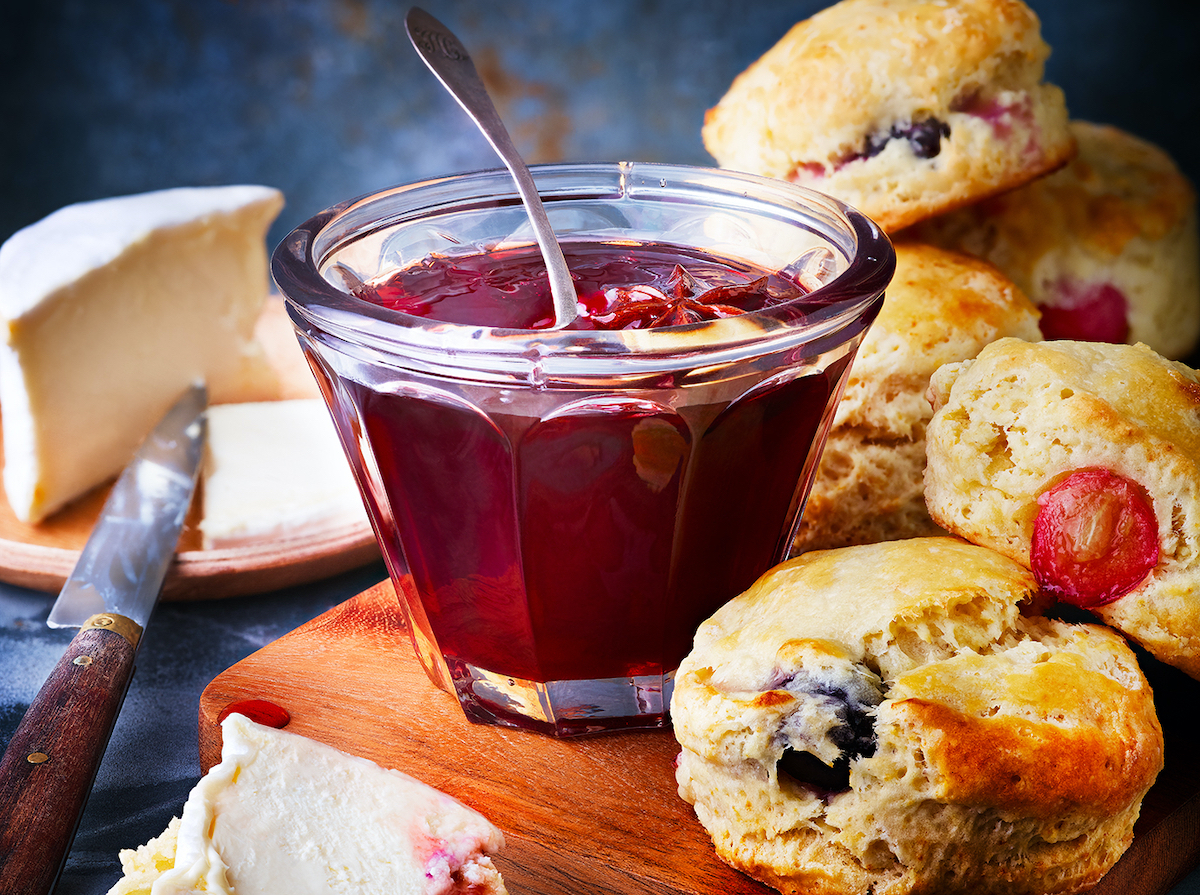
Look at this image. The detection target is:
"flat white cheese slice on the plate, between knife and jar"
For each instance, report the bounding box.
[200,398,370,549]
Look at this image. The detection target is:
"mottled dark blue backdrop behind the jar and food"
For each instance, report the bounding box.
[0,0,1200,245]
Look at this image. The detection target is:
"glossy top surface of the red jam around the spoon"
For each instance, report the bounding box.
[355,242,805,330]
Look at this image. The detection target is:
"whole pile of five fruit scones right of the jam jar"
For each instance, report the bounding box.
[672,0,1200,895]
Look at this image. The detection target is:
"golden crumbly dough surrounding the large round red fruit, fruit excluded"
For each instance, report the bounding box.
[925,340,1200,678]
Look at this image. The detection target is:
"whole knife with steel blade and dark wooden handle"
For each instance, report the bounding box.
[0,385,208,895]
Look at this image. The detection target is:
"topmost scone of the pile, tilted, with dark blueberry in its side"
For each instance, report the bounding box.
[702,0,1074,233]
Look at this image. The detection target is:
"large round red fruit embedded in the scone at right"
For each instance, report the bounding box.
[1030,468,1159,608]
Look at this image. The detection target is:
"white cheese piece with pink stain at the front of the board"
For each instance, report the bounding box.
[112,714,505,895]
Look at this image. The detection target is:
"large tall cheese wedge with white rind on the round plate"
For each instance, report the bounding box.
[0,186,283,522]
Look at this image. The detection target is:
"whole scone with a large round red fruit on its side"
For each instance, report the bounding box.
[925,338,1200,678]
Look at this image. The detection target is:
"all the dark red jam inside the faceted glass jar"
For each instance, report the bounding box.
[333,242,849,700]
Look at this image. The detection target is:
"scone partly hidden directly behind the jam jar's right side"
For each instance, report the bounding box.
[793,242,1039,552]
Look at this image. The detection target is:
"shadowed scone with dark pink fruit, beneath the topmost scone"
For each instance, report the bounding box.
[917,121,1200,359]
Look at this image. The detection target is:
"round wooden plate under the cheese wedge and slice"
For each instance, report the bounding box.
[0,295,379,600]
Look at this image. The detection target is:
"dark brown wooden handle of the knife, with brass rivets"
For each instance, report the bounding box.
[0,617,140,895]
